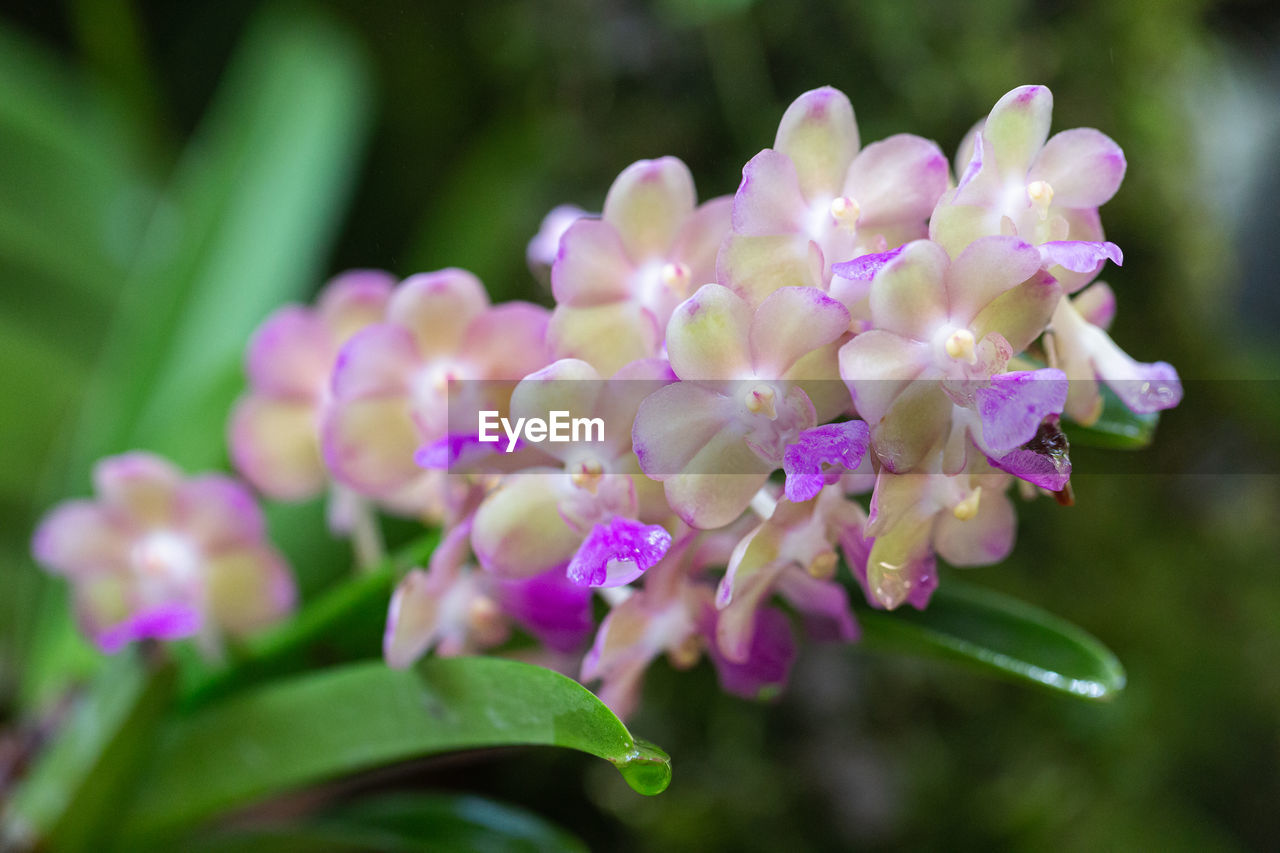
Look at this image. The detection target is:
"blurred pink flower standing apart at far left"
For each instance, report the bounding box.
[32,452,296,653]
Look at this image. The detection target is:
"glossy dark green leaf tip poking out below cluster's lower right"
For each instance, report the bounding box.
[858,579,1125,699]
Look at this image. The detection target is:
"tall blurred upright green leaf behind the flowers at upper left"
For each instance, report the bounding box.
[67,4,369,467]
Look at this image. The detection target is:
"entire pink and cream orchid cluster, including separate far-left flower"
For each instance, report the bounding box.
[35,86,1181,713]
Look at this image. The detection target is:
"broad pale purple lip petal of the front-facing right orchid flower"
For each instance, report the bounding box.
[975,368,1068,453]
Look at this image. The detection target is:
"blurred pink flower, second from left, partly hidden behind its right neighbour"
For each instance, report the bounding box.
[229,270,396,501]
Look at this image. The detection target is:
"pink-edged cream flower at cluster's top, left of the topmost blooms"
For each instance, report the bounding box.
[550,158,730,377]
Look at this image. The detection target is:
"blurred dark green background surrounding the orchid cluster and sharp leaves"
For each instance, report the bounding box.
[0,0,1280,850]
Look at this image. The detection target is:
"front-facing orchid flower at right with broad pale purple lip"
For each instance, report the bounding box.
[840,237,1066,474]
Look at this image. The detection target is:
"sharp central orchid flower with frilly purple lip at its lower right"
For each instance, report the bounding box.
[632,284,865,528]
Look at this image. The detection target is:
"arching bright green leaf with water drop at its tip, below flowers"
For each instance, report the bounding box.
[124,657,671,841]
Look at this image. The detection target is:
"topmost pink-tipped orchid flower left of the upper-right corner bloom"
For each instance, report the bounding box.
[717,87,947,302]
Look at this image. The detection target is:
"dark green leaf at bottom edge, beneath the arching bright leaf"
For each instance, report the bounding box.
[183,794,588,853]
